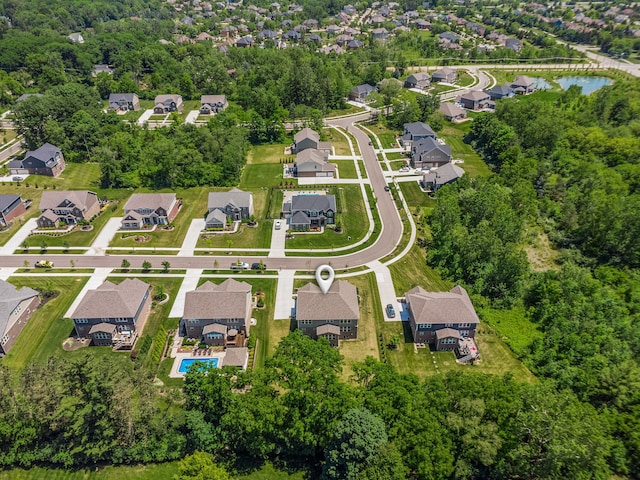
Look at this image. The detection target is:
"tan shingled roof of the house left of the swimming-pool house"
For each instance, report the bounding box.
[71,278,149,318]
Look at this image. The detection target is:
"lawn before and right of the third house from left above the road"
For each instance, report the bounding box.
[109,187,214,248]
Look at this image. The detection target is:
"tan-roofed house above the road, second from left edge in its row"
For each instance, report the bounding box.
[36,190,100,228]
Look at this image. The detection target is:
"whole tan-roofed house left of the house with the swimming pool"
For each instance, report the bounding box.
[71,278,151,349]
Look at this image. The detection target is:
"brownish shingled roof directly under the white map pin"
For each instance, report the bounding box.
[296,280,360,320]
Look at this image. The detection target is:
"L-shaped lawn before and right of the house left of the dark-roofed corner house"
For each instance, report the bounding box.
[196,188,272,248]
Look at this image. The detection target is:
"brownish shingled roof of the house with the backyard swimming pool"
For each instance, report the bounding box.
[182,278,251,319]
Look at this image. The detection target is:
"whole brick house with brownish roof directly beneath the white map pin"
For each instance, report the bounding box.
[296,280,360,347]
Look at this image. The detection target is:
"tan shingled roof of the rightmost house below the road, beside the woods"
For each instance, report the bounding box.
[405,285,480,325]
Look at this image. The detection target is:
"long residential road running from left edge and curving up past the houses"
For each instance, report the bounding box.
[0,113,402,270]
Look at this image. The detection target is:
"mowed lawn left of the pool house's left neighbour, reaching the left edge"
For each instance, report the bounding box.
[2,277,89,370]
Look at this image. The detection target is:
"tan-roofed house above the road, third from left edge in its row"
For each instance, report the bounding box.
[122,193,181,229]
